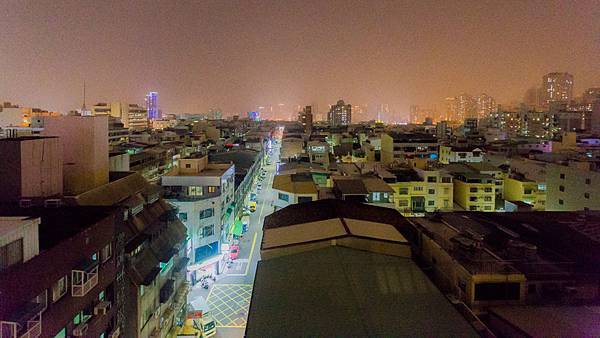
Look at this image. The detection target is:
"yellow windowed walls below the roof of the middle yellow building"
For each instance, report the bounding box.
[454,178,496,212]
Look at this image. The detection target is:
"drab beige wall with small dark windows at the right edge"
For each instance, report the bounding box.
[546,164,600,211]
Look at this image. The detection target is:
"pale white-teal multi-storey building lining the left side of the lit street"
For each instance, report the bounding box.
[161,155,235,274]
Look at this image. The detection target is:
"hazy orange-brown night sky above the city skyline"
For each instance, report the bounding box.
[0,0,600,117]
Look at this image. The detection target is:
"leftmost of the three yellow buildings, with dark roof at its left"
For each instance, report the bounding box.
[378,168,453,216]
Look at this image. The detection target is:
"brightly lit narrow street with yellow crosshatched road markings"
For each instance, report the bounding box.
[188,135,281,337]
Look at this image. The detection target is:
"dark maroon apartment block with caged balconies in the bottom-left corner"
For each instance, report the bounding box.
[0,209,123,338]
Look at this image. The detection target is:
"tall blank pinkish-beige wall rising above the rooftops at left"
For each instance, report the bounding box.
[43,116,109,195]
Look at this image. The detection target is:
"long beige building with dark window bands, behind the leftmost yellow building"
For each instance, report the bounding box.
[381,132,438,164]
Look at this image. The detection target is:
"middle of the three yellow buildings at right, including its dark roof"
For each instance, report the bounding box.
[453,173,496,212]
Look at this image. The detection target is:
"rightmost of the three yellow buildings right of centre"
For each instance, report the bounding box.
[504,177,546,210]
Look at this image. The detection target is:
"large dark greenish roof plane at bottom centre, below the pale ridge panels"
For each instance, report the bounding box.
[246,246,477,337]
